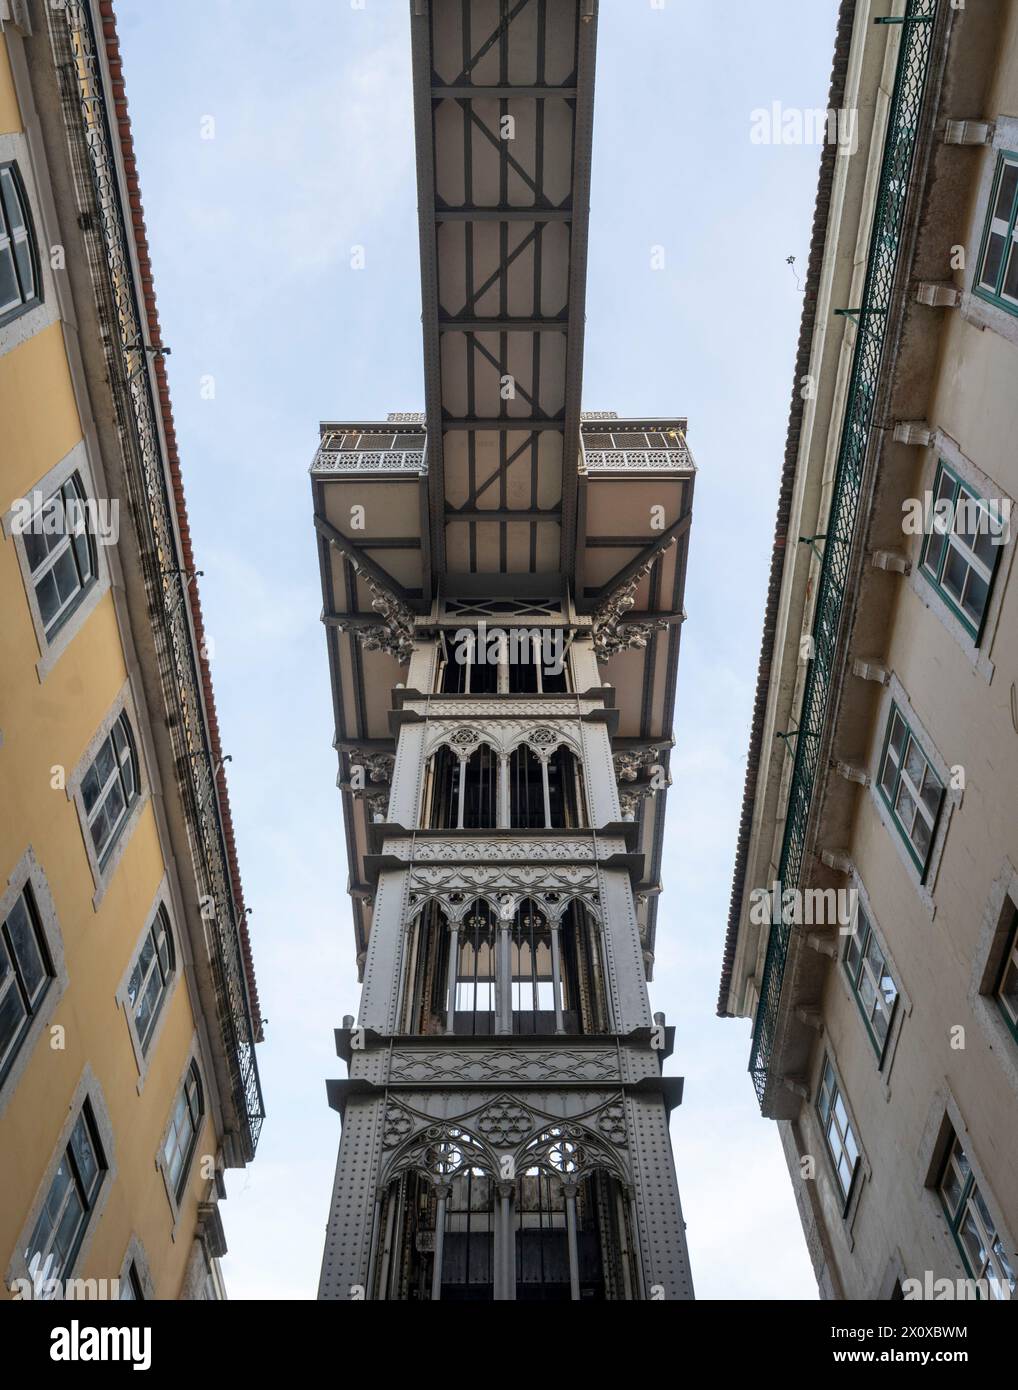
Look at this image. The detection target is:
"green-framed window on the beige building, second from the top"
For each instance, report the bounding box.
[919,459,1003,644]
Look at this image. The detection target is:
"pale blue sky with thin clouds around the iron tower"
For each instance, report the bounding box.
[115,0,836,1300]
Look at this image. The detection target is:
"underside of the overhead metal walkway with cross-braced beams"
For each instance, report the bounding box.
[412,0,597,592]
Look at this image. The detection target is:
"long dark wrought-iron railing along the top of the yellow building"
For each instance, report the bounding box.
[55,0,264,1158]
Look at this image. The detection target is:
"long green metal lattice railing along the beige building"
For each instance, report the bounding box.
[750,0,939,1104]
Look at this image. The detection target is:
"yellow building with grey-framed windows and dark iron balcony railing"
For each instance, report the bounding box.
[0,0,261,1300]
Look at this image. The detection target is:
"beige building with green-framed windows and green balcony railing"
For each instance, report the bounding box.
[719,0,1018,1300]
